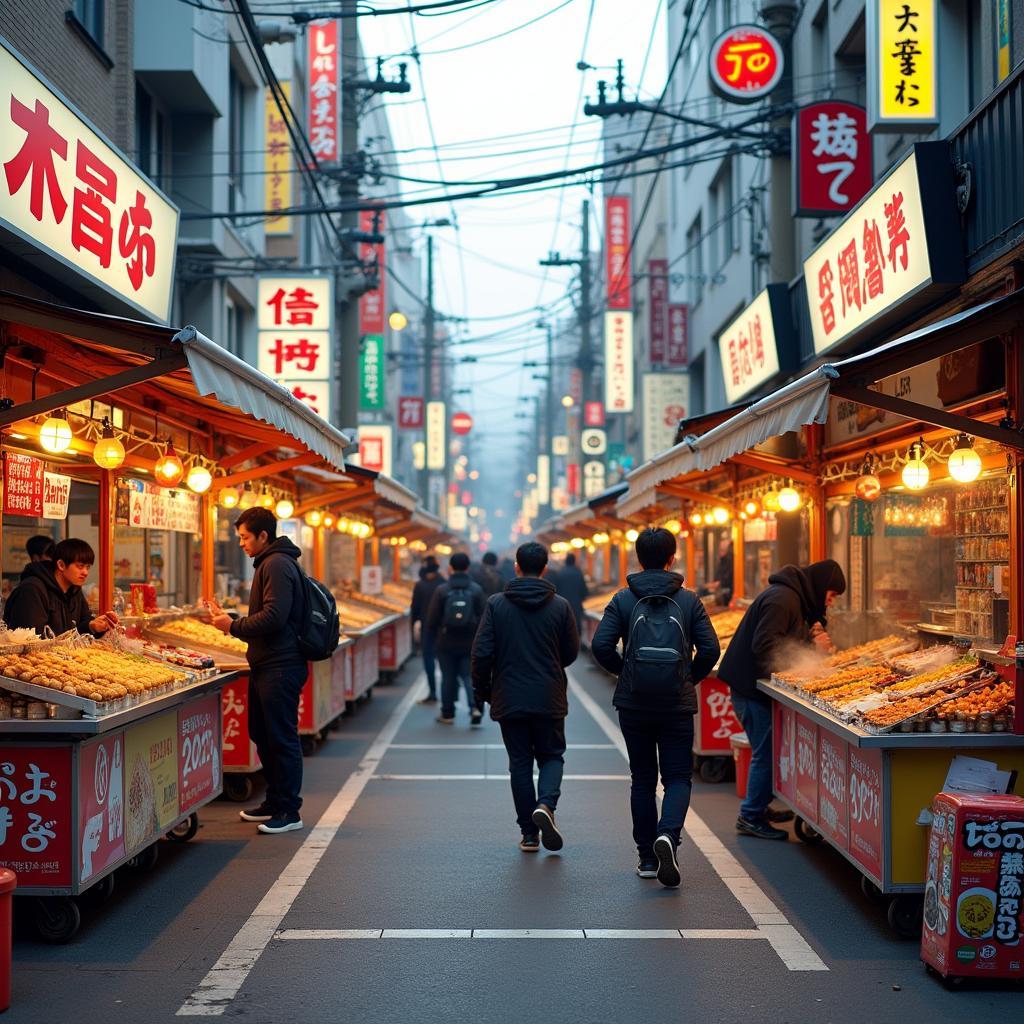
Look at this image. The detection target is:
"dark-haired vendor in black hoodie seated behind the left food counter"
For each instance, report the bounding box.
[3,537,118,637]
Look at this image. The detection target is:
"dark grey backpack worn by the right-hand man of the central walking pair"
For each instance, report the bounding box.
[622,594,692,698]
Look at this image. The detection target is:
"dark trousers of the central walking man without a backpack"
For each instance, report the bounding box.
[499,715,565,836]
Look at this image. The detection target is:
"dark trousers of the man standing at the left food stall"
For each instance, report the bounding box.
[249,665,307,814]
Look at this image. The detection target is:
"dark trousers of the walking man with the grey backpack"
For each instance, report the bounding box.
[618,708,693,857]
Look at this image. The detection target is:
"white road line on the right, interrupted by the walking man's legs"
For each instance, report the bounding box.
[568,676,828,971]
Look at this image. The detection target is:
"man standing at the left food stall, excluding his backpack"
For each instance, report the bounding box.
[211,507,308,836]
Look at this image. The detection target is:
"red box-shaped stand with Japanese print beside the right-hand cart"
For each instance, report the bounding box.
[921,793,1024,981]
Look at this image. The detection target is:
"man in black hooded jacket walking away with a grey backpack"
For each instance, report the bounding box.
[591,528,719,888]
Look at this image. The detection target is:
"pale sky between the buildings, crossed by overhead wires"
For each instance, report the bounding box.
[359,0,667,539]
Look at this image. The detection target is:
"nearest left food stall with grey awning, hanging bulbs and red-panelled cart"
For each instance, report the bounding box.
[0,293,347,941]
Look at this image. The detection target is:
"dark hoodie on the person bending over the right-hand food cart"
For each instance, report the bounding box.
[718,558,846,703]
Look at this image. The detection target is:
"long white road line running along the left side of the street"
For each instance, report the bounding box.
[177,671,422,1017]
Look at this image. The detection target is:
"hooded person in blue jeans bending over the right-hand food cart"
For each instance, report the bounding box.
[718,558,846,840]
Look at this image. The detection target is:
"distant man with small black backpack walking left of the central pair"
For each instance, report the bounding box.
[426,551,486,728]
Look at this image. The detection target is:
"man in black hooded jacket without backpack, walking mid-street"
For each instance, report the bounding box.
[473,543,580,853]
